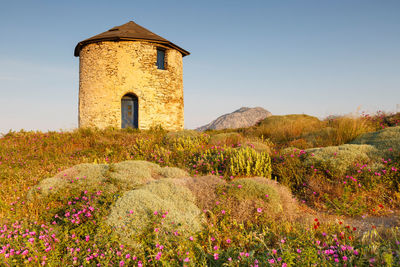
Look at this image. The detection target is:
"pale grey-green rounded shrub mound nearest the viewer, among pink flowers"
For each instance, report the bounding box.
[107,179,203,245]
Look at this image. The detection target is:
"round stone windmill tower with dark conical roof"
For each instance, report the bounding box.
[74,21,189,130]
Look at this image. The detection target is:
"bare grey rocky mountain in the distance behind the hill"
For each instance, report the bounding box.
[196,107,272,131]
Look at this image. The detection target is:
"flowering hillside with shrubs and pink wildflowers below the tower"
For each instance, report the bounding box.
[0,115,400,266]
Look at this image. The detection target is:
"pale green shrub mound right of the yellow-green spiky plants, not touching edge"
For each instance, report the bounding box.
[304,144,377,175]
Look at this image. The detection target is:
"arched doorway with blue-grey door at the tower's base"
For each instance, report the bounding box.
[121,94,139,128]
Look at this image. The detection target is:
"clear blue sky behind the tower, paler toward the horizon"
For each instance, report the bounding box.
[0,0,400,132]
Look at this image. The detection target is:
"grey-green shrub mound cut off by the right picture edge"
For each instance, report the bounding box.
[351,126,400,157]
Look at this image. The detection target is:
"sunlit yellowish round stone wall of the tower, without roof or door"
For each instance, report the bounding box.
[79,41,184,130]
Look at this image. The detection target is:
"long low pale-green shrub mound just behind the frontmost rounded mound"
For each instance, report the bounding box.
[28,160,189,199]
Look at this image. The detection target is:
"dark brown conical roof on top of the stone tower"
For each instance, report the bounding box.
[74,21,190,57]
